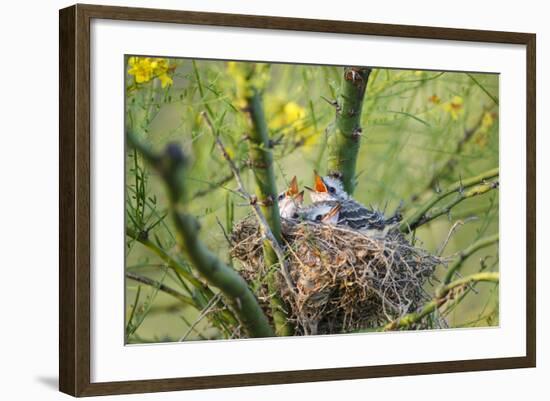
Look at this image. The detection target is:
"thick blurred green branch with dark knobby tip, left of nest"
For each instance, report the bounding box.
[126,132,273,337]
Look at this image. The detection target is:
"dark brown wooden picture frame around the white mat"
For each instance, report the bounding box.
[59,4,536,396]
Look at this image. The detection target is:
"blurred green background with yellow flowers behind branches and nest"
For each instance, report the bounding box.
[126,57,499,343]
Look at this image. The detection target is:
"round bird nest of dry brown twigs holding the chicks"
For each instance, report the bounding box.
[231,216,441,335]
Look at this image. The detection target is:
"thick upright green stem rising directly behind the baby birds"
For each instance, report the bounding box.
[328,67,371,194]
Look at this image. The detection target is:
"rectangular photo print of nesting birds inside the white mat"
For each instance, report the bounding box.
[125,55,499,344]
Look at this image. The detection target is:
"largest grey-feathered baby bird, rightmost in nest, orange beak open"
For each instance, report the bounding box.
[306,171,400,230]
